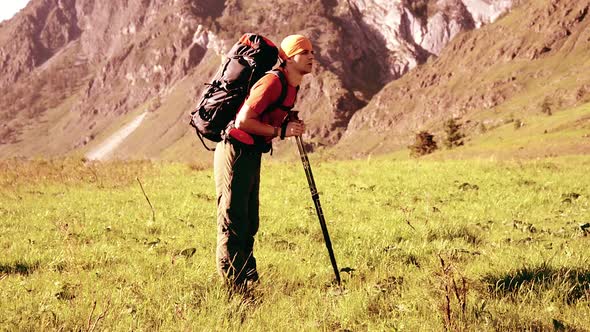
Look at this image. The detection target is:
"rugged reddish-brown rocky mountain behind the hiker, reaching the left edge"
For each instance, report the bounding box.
[0,0,536,159]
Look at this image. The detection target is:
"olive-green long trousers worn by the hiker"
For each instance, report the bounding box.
[214,141,261,286]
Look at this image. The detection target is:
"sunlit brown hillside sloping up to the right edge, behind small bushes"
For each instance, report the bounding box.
[338,0,590,155]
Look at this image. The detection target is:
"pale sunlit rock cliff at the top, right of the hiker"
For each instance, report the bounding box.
[337,0,512,81]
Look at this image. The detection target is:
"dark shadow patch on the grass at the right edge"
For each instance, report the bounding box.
[483,263,590,304]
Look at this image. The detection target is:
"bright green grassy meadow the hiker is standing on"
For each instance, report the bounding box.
[0,155,590,331]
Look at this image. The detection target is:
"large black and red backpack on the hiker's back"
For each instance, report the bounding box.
[190,33,286,151]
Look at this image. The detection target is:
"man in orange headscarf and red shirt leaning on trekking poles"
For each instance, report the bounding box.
[214,35,314,288]
